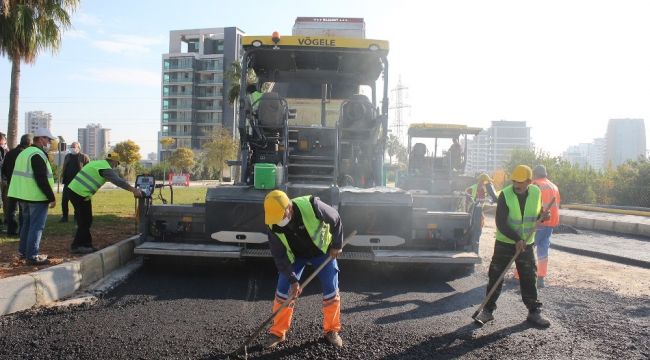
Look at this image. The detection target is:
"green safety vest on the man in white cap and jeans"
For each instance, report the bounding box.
[8,146,54,201]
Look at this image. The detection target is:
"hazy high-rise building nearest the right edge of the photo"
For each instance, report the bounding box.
[605,119,646,166]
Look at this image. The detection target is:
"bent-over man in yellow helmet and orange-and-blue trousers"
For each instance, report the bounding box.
[264,190,343,348]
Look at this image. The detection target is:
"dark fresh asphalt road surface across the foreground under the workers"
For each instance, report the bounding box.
[0,231,650,359]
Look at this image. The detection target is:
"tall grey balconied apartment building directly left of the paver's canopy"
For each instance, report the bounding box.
[158,27,243,161]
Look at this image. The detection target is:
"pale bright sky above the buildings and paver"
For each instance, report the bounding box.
[0,0,650,156]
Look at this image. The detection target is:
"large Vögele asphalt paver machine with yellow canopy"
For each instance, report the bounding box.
[136,34,479,264]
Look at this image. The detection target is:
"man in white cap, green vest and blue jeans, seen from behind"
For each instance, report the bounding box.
[9,128,56,265]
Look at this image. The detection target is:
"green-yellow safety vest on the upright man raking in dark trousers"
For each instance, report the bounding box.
[497,185,542,245]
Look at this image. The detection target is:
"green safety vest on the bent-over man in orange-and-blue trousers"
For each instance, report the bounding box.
[269,195,332,264]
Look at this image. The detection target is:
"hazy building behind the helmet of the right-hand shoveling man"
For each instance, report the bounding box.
[466,120,531,174]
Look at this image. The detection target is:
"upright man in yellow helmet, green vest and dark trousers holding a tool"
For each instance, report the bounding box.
[476,165,550,327]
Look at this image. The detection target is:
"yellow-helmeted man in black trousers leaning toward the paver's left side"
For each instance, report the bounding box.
[67,152,142,254]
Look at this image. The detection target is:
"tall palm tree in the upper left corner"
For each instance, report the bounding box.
[0,0,79,148]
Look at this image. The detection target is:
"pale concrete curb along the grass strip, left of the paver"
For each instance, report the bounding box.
[0,235,140,316]
